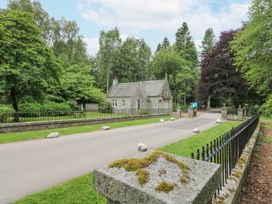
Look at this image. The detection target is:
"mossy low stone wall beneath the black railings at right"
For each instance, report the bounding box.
[213,122,260,204]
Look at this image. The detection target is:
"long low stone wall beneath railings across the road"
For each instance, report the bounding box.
[0,115,168,133]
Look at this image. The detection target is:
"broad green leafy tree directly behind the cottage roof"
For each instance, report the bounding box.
[120,38,151,82]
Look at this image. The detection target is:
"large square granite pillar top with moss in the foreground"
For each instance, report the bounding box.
[94,151,221,204]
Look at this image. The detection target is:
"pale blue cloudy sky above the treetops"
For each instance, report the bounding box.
[78,0,250,53]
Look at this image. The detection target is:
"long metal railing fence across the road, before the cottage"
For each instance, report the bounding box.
[0,109,170,123]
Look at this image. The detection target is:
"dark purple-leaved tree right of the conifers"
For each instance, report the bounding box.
[199,31,251,107]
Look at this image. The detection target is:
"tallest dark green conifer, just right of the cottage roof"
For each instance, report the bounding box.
[175,22,198,68]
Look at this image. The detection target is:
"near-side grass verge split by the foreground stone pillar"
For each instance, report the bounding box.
[15,121,240,204]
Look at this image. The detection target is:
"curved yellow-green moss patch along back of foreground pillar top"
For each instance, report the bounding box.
[108,151,190,188]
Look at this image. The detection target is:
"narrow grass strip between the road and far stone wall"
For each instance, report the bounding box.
[0,116,171,144]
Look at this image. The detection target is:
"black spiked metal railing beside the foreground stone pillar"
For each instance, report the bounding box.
[191,114,259,193]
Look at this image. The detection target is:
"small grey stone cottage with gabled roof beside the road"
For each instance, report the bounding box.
[107,80,172,114]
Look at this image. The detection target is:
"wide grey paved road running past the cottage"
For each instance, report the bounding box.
[0,113,219,204]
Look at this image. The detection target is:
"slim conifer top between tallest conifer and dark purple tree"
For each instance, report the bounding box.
[200,28,215,58]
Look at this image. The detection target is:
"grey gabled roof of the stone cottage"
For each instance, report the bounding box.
[108,80,167,97]
